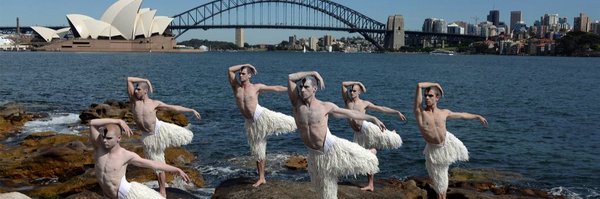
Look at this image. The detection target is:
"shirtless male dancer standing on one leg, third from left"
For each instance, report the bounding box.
[227,64,296,187]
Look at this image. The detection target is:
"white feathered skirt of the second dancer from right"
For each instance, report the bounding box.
[354,120,402,149]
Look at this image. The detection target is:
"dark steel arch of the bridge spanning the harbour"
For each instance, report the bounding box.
[169,0,387,50]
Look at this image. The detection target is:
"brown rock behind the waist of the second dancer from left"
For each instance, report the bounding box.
[79,100,189,126]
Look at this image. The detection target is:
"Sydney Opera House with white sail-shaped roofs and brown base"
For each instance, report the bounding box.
[31,0,176,52]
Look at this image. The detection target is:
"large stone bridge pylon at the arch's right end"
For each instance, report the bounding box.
[384,15,405,51]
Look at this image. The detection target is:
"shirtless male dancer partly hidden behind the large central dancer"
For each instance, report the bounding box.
[342,81,406,191]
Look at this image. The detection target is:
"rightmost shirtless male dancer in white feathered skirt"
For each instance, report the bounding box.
[414,82,488,199]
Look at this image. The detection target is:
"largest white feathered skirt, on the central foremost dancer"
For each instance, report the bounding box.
[308,130,379,199]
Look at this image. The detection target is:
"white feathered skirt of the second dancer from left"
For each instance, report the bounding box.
[142,119,194,166]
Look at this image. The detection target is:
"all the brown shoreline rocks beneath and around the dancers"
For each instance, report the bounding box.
[0,100,565,198]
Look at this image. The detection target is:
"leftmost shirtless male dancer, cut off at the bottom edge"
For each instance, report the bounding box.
[90,118,189,199]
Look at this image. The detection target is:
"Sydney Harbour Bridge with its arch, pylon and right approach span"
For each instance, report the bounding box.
[0,0,485,50]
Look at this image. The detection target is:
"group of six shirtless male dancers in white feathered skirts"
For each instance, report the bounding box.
[90,64,487,199]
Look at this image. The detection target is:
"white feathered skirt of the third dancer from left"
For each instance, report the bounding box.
[244,104,296,160]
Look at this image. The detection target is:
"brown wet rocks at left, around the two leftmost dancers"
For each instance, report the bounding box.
[0,101,204,198]
